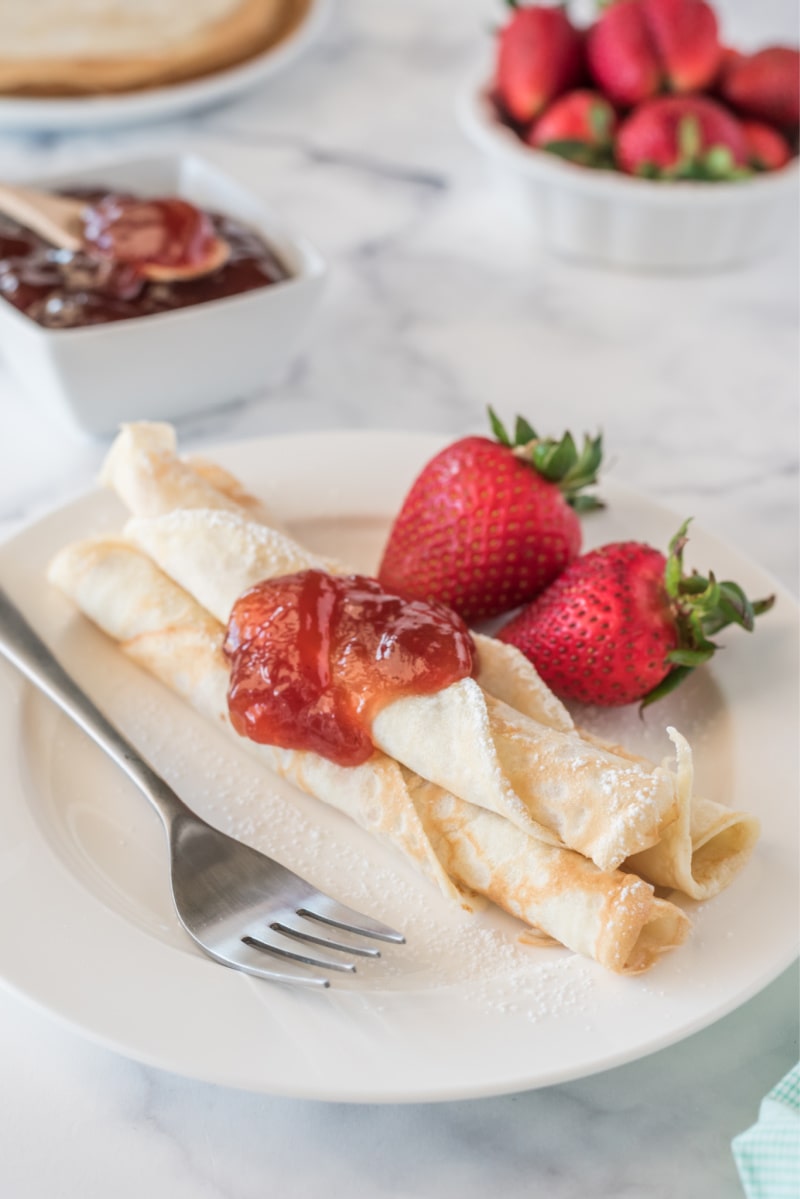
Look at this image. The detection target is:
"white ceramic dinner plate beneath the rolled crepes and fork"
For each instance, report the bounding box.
[0,433,798,1102]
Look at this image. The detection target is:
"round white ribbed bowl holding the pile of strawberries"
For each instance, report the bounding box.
[458,84,799,271]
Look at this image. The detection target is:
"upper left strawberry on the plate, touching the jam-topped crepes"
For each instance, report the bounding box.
[378,412,602,621]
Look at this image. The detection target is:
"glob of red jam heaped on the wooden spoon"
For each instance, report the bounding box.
[83,193,216,267]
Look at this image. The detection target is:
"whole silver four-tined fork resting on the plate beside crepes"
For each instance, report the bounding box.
[0,589,404,987]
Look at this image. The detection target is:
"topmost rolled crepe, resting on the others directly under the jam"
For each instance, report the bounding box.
[125,508,676,869]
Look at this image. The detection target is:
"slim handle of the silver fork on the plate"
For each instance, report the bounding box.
[0,588,190,830]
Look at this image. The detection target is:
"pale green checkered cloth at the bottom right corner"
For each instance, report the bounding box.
[732,1065,800,1199]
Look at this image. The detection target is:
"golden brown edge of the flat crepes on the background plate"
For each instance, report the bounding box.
[0,0,312,97]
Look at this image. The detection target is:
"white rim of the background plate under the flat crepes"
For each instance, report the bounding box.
[0,0,331,132]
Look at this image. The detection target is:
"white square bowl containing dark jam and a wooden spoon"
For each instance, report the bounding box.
[0,155,325,436]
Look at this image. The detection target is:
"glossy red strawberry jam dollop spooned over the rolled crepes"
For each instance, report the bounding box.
[224,570,475,766]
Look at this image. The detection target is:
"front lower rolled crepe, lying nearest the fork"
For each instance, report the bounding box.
[49,538,690,974]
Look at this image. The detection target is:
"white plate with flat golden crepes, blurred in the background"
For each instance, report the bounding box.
[0,0,332,132]
